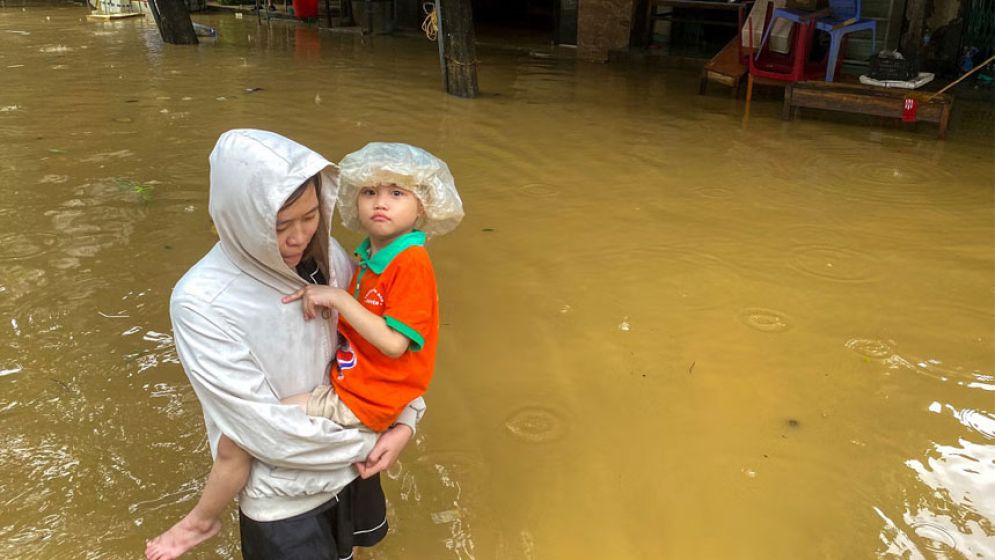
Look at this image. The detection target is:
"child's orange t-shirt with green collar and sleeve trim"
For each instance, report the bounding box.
[330,231,439,432]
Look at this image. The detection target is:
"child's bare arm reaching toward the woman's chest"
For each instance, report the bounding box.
[283,284,411,358]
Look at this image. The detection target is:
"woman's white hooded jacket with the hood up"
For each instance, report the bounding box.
[170,130,424,521]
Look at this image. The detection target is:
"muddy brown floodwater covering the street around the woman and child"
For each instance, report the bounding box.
[0,3,995,560]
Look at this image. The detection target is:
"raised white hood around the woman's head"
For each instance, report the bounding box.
[208,129,339,291]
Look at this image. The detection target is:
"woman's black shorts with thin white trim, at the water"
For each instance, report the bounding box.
[238,475,387,560]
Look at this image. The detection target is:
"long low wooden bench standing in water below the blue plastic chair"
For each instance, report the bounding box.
[782,82,954,140]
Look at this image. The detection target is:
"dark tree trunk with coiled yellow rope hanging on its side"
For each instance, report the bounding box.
[439,0,478,98]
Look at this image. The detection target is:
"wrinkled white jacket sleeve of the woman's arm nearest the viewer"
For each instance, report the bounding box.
[171,299,374,470]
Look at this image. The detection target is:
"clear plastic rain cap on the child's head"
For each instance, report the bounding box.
[338,142,463,237]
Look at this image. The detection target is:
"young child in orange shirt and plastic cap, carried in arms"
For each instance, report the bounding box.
[146,142,463,560]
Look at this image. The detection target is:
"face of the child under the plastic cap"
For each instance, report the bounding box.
[356,185,422,249]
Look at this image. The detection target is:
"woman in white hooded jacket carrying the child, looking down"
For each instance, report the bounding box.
[146,130,424,560]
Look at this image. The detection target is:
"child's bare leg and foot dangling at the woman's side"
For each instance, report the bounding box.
[145,436,252,560]
